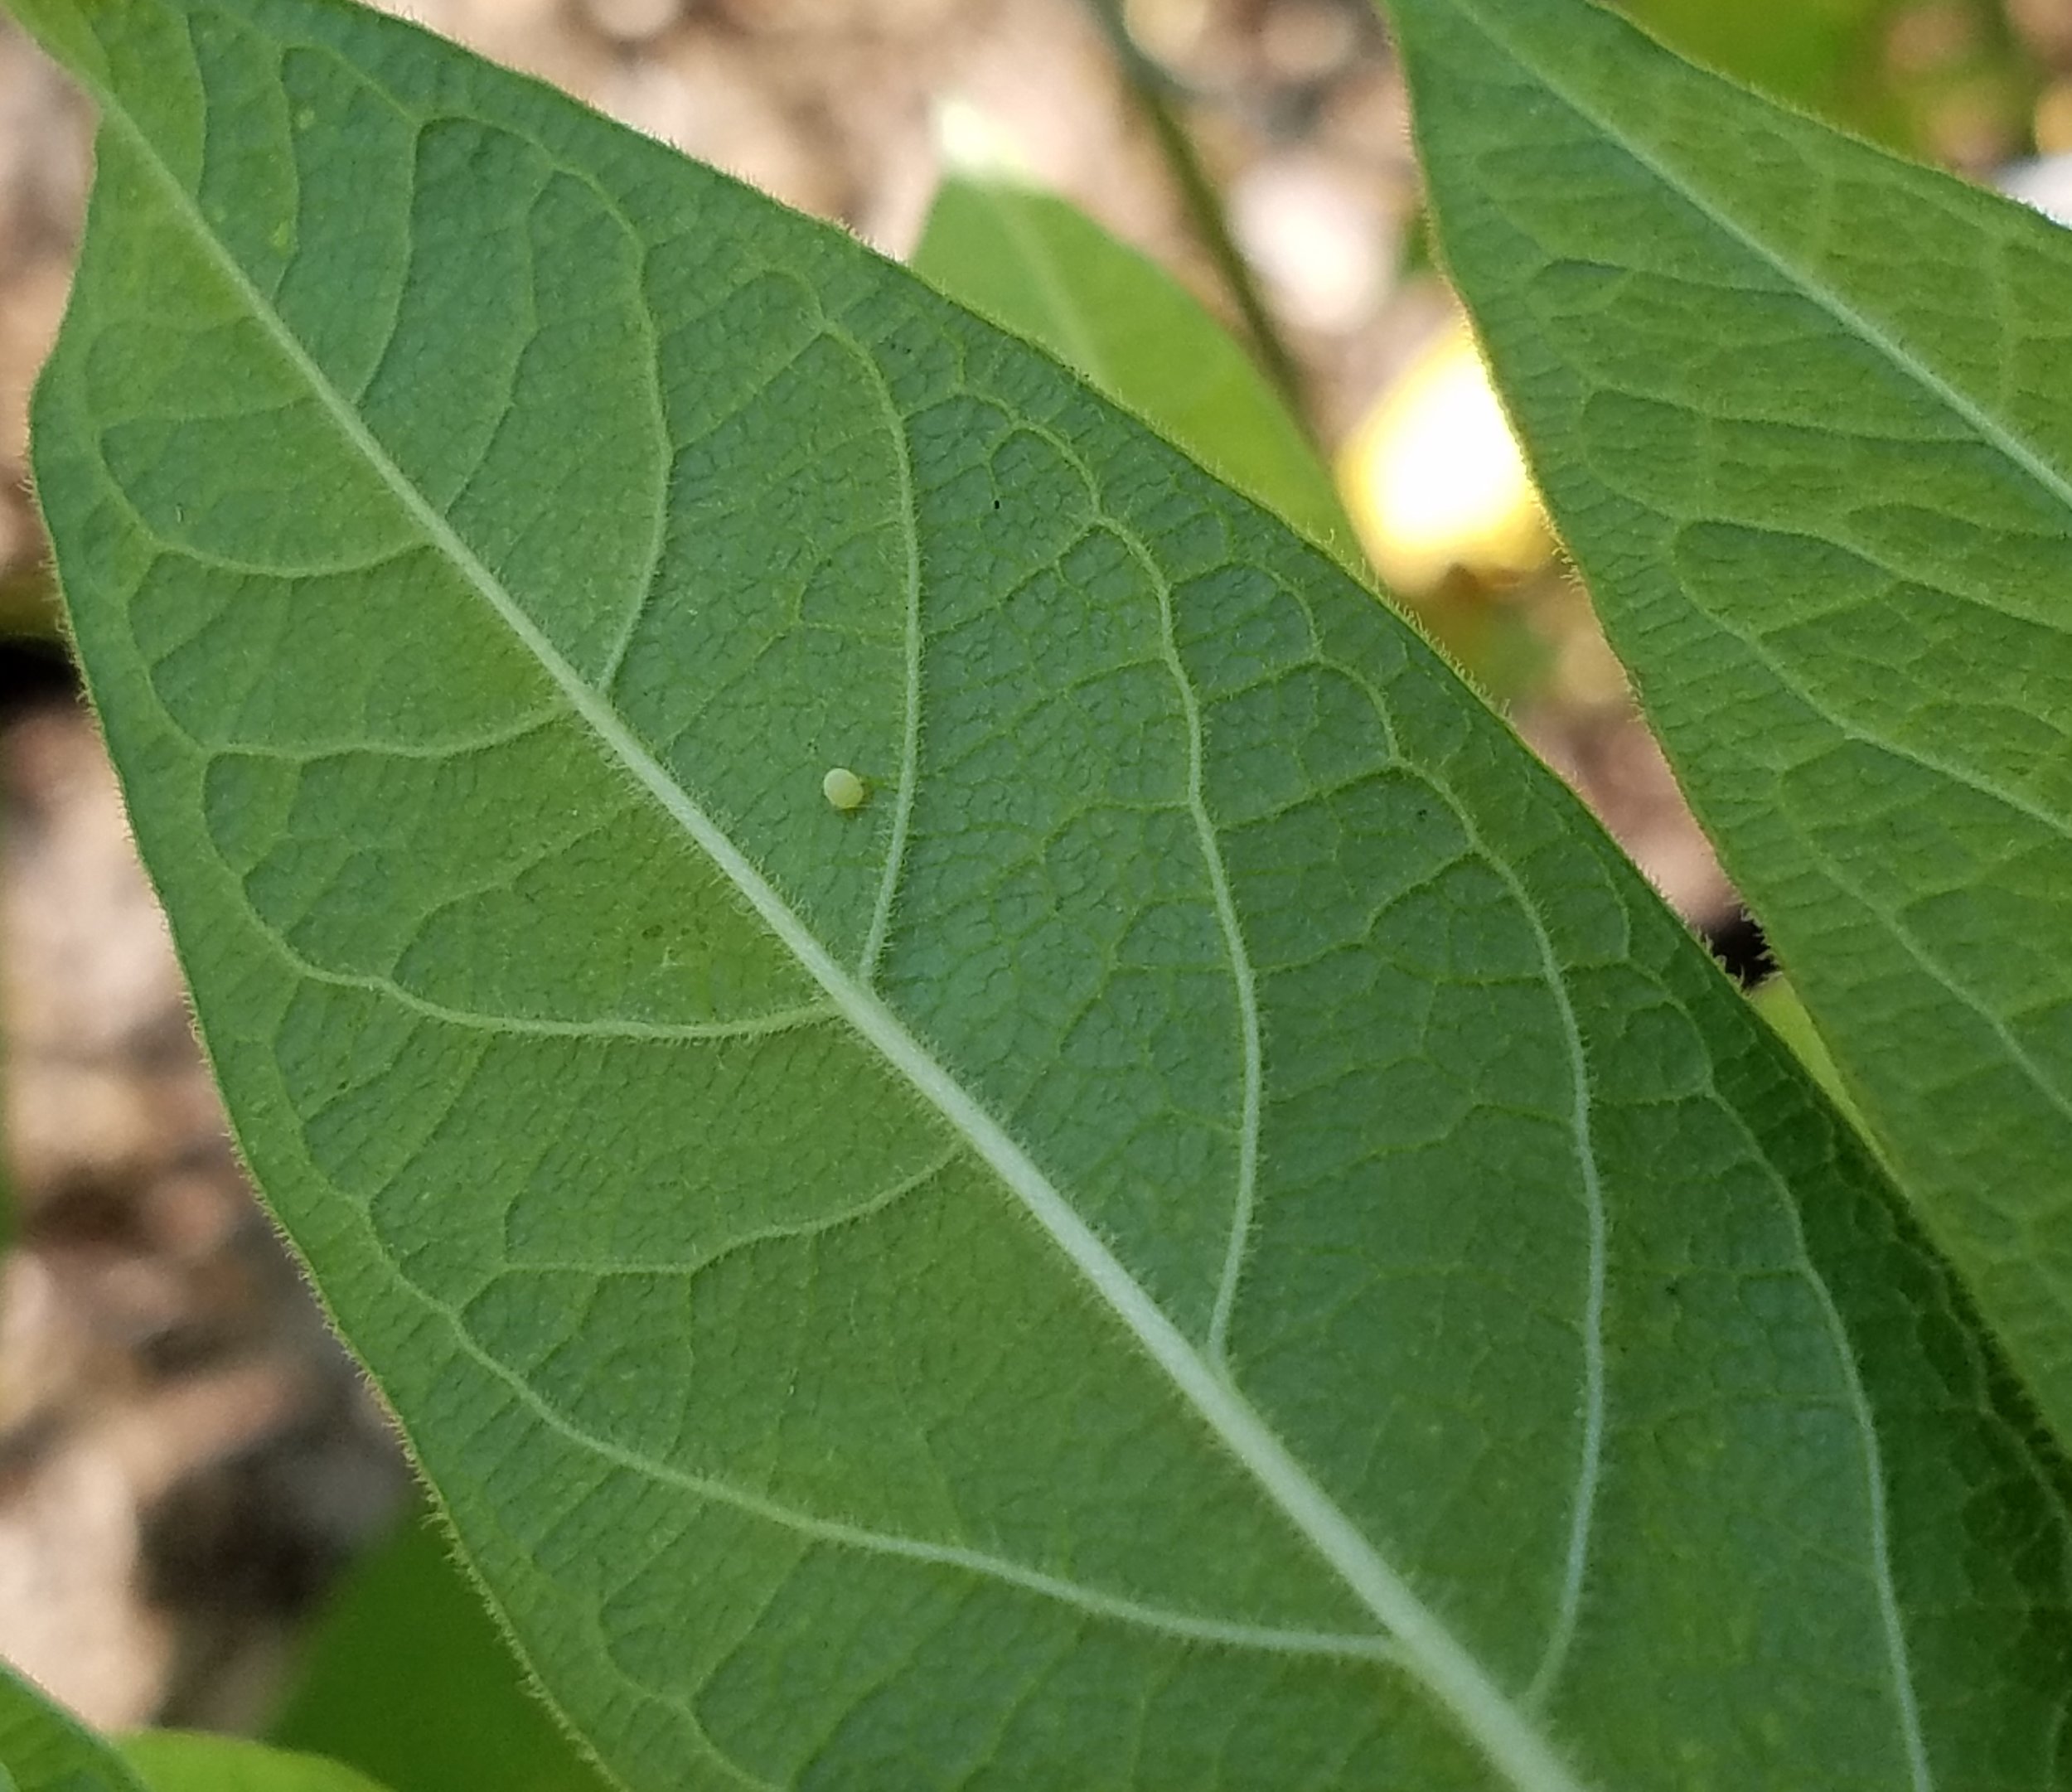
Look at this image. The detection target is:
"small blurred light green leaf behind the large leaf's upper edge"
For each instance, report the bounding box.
[914,178,1368,576]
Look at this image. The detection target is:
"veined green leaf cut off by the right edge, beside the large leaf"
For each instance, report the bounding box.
[1395,0,2072,1436]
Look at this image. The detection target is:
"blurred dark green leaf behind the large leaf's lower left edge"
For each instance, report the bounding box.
[272,1514,605,1792]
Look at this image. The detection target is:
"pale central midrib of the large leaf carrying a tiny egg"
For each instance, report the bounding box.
[99,89,1587,1792]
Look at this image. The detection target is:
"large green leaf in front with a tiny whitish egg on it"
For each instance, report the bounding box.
[25,0,2072,1792]
